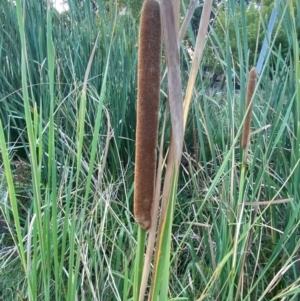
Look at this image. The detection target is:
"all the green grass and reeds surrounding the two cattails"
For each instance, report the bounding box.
[0,0,300,301]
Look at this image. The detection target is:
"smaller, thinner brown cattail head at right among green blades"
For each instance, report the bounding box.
[242,67,257,149]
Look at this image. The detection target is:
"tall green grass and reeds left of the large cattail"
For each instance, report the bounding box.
[0,1,136,300]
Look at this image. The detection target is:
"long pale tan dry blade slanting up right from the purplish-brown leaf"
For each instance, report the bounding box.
[183,0,212,128]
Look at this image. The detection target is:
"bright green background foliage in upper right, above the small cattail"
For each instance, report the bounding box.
[206,0,300,73]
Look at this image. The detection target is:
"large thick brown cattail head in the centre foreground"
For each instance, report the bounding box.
[134,0,161,230]
